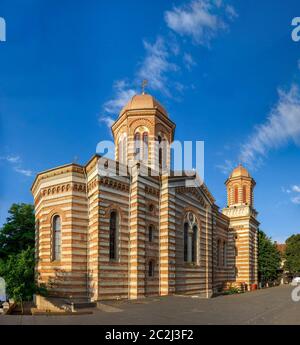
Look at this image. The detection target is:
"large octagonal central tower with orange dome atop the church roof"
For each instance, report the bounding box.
[112,90,175,171]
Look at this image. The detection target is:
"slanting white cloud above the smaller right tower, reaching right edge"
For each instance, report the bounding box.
[240,85,300,168]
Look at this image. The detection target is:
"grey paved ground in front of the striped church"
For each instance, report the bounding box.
[0,286,300,325]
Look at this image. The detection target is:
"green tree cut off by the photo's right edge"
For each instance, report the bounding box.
[285,235,300,276]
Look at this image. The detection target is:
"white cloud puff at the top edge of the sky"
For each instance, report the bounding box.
[165,0,237,45]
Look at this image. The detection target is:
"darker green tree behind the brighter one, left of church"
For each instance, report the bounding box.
[0,204,35,259]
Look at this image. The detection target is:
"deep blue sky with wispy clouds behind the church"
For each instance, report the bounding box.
[0,0,300,242]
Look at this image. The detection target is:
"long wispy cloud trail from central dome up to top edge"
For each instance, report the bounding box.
[99,0,236,127]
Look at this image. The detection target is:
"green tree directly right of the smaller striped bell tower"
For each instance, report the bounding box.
[258,230,281,284]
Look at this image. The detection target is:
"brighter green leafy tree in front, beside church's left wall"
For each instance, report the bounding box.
[0,248,36,301]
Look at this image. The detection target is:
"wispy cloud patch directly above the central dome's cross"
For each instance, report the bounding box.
[137,37,179,96]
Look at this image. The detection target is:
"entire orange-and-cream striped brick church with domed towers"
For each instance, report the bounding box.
[31,92,259,301]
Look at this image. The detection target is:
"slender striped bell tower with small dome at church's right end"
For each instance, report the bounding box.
[222,165,259,289]
